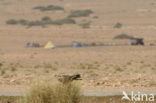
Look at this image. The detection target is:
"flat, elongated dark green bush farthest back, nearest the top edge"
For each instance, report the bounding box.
[33,5,64,11]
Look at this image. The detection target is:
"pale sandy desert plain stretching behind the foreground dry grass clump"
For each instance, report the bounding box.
[0,0,156,91]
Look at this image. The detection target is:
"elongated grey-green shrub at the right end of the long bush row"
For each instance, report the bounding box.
[53,18,76,25]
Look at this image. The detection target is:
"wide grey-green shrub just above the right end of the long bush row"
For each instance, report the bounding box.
[68,9,93,17]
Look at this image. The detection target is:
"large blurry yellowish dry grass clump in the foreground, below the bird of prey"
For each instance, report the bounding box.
[22,83,81,103]
